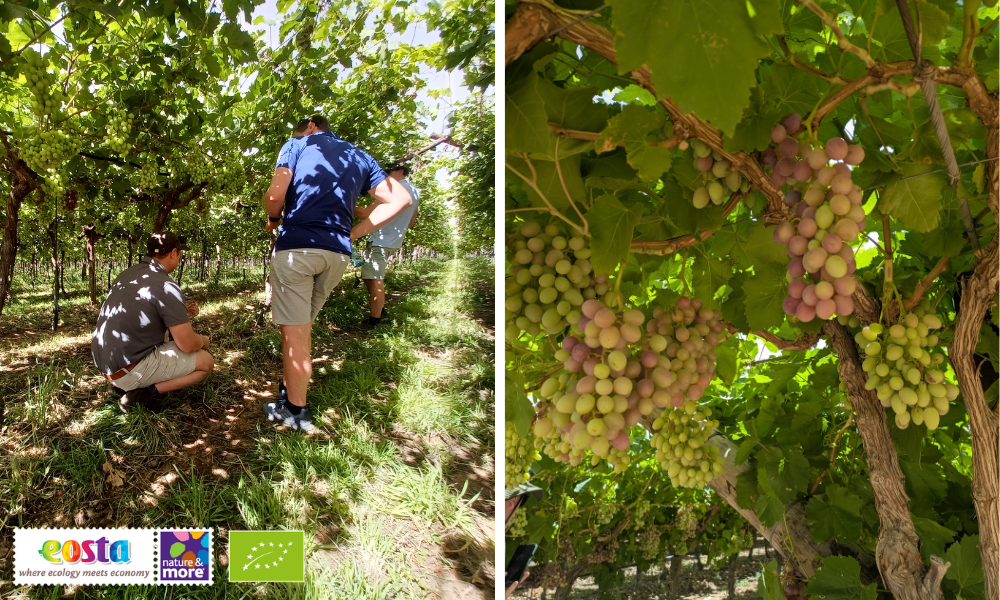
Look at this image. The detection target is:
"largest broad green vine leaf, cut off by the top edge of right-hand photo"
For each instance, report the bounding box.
[609,0,781,135]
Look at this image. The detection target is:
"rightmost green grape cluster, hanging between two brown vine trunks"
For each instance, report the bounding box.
[854,298,959,430]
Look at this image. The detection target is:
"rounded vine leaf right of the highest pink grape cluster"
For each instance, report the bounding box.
[878,164,945,233]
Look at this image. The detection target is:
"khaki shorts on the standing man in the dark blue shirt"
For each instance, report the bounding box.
[270,248,350,325]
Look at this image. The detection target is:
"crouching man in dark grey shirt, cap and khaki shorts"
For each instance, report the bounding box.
[90,232,215,412]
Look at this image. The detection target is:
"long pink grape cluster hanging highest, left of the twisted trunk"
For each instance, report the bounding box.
[761,114,866,322]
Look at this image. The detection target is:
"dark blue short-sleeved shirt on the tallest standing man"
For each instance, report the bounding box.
[274,131,386,256]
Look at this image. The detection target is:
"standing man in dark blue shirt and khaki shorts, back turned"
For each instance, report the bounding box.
[264,115,412,432]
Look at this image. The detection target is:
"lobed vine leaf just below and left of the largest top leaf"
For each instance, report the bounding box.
[594,104,673,181]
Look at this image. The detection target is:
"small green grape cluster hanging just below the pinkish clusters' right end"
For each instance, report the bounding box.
[650,400,724,488]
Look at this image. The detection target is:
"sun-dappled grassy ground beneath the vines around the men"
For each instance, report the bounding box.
[0,260,495,599]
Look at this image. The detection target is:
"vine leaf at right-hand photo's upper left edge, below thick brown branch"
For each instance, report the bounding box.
[503,69,549,154]
